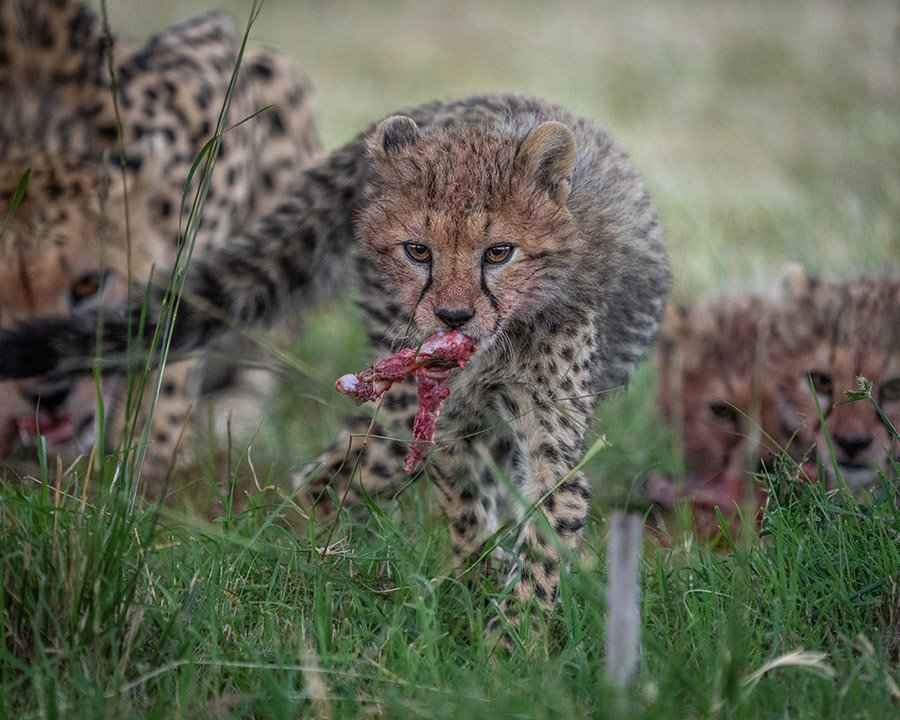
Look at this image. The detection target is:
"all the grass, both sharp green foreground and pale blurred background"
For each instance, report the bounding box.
[0,0,900,720]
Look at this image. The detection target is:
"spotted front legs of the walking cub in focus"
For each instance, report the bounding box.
[428,386,593,615]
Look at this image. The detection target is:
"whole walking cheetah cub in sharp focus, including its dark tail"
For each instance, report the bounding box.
[0,96,670,607]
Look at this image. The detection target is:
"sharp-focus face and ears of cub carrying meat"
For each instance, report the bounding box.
[359,116,578,350]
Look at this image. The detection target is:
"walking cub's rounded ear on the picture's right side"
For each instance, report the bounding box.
[516,120,575,205]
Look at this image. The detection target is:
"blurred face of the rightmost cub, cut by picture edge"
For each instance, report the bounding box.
[779,271,900,490]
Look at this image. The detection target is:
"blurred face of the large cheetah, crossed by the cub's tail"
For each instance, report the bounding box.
[0,155,163,459]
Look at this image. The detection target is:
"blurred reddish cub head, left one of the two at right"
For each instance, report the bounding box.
[656,294,814,477]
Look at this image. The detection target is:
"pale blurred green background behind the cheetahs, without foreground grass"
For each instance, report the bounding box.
[93,0,900,490]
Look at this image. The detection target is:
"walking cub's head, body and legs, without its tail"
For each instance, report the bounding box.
[306,101,668,616]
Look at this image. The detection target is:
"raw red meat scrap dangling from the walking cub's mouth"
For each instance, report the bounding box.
[335,330,475,473]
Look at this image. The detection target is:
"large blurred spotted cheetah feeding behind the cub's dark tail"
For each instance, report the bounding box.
[0,0,319,484]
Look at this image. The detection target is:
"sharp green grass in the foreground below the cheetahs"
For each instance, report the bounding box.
[0,450,900,718]
